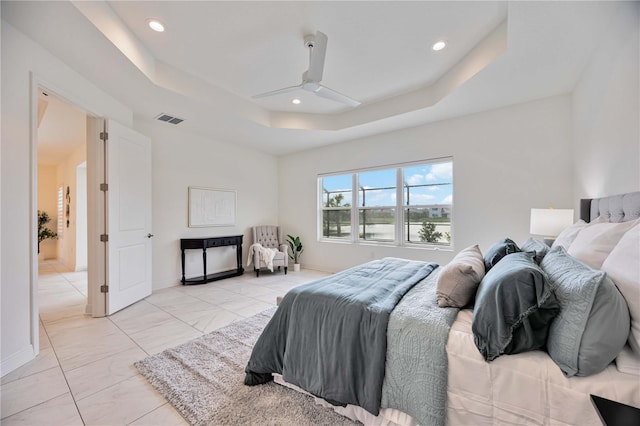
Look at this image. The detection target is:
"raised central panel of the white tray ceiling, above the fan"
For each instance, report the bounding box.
[109,1,507,113]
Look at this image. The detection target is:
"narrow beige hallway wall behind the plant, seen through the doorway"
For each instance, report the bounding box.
[38,164,58,260]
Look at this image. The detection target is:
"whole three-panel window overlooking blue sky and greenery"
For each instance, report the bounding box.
[318,159,453,247]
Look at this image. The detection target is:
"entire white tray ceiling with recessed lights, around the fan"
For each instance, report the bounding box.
[2,1,617,155]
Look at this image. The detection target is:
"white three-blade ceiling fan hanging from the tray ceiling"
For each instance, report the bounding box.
[253,31,360,107]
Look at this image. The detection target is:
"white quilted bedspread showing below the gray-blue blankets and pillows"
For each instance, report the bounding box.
[273,309,640,426]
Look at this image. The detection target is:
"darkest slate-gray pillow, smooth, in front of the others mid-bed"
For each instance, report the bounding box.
[471,253,560,361]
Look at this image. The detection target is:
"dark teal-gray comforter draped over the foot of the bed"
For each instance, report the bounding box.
[245,258,436,415]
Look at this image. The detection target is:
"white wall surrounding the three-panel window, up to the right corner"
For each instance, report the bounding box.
[280,96,573,271]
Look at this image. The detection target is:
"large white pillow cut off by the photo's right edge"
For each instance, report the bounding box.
[601,221,640,357]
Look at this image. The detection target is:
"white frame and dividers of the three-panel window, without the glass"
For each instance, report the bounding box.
[317,157,455,250]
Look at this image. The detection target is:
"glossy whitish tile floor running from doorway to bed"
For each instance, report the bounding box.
[0,262,326,426]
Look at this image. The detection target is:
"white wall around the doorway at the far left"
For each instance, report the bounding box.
[0,21,133,375]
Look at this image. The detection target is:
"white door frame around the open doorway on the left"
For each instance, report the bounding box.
[29,71,104,357]
